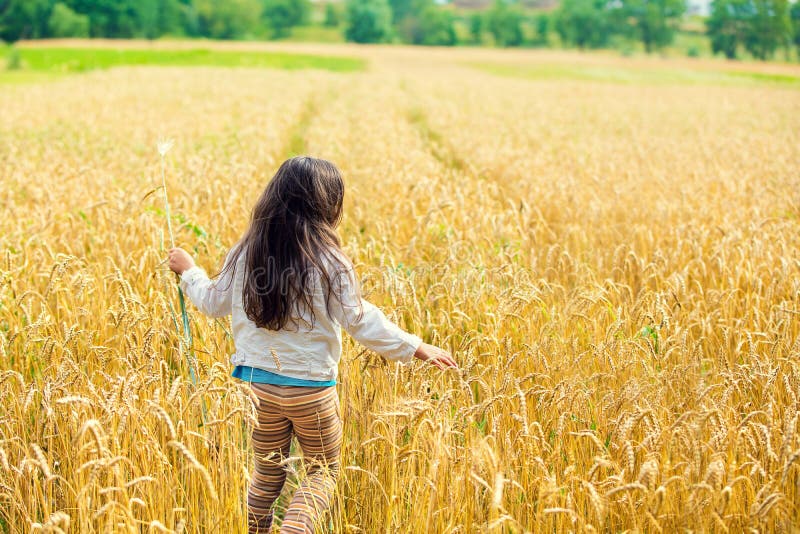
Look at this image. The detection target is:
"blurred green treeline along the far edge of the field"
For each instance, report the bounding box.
[0,0,800,59]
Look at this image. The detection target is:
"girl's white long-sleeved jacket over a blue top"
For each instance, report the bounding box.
[180,249,422,380]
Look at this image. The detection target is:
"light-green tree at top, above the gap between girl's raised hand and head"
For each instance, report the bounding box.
[194,0,263,39]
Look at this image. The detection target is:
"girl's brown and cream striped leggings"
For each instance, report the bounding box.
[247,383,342,534]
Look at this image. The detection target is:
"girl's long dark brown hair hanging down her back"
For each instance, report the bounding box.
[222,156,354,330]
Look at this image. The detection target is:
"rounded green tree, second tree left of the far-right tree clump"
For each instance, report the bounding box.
[553,0,616,49]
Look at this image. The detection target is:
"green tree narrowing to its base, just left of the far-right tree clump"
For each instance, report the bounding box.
[622,0,686,53]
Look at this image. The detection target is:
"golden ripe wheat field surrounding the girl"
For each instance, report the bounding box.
[0,45,800,533]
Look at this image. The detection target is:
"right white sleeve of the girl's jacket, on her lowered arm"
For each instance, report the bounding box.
[330,256,422,362]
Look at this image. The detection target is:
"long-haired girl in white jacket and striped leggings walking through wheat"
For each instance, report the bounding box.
[169,157,456,533]
